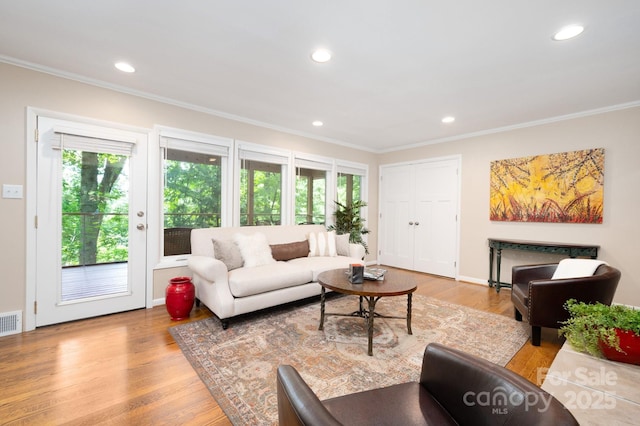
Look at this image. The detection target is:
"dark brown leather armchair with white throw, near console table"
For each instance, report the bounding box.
[511,263,620,346]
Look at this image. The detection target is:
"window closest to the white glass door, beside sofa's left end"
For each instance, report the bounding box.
[161,131,231,256]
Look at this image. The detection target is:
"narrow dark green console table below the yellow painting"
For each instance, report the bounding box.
[489,238,600,292]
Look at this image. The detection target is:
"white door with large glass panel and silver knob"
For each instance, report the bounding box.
[36,117,147,326]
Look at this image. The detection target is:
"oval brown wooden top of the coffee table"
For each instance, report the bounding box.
[318,268,418,297]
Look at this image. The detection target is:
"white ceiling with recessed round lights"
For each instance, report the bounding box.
[0,0,640,152]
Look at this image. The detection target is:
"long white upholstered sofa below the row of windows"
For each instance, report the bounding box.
[188,225,364,329]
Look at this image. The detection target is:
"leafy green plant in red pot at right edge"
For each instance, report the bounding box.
[559,299,640,365]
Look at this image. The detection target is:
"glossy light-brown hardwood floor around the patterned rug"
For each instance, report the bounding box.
[0,274,561,425]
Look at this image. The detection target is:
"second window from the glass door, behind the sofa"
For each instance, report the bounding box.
[238,147,289,226]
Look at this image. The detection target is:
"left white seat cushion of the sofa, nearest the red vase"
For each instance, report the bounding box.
[229,261,312,297]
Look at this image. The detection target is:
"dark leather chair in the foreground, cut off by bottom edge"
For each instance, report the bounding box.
[277,343,578,426]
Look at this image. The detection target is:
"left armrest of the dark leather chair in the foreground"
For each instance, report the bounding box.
[276,365,341,426]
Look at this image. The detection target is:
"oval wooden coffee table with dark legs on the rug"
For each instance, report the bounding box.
[318,269,417,356]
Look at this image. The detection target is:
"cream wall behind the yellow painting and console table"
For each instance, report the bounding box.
[380,107,640,306]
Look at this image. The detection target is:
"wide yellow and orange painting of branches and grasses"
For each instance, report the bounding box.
[489,148,604,223]
